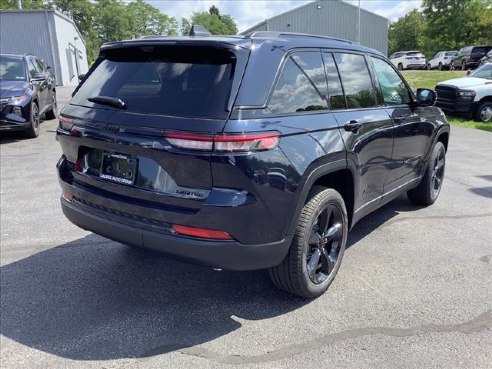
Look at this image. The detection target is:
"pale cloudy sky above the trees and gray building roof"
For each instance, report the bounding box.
[146,0,422,32]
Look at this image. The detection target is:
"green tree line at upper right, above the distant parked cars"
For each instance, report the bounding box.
[388,0,492,58]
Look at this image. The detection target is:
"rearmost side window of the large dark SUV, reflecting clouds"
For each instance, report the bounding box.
[268,52,328,113]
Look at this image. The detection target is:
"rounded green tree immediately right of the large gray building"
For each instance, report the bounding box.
[388,10,426,54]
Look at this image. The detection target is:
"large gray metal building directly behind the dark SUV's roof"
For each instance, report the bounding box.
[241,0,388,55]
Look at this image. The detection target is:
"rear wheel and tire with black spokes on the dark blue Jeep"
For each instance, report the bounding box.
[269,186,348,299]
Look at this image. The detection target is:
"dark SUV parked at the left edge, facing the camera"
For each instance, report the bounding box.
[0,54,57,138]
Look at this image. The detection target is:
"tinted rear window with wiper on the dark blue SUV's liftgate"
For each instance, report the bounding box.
[71,47,240,119]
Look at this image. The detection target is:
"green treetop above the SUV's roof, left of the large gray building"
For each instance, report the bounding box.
[182,5,238,35]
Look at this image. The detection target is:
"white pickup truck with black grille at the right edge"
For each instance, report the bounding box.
[436,63,492,122]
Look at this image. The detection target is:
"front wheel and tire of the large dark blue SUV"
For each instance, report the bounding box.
[407,142,446,205]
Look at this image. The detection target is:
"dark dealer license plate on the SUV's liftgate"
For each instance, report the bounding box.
[99,152,138,185]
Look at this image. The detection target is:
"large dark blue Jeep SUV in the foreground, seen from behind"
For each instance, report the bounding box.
[57,32,449,298]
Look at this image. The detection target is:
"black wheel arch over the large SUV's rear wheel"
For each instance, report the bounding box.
[287,159,354,235]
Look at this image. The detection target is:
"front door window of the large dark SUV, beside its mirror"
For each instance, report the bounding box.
[371,58,410,105]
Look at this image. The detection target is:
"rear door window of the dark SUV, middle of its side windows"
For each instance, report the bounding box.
[335,53,377,108]
